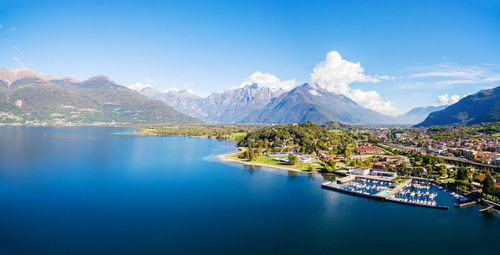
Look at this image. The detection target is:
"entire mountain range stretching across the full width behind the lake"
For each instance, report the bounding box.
[0,68,500,126]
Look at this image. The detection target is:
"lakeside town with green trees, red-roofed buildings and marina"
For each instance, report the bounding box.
[224,122,500,211]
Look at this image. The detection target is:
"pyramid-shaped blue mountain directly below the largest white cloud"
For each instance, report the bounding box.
[241,84,392,124]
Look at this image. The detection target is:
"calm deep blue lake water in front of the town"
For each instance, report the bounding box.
[0,127,500,254]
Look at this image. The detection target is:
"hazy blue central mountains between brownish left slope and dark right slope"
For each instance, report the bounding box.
[140,83,445,125]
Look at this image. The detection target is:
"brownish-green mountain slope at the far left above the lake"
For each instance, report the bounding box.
[0,68,198,125]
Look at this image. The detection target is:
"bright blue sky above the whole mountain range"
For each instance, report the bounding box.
[0,0,500,114]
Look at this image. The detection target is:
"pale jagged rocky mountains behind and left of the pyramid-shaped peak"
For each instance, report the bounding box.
[140,84,284,122]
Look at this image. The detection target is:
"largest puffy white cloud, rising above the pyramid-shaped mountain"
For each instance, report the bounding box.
[309,51,397,115]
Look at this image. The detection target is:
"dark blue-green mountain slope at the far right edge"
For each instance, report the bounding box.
[416,87,500,127]
